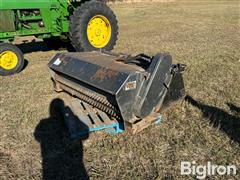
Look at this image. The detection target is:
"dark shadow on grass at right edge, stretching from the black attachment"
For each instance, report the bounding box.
[185,96,240,144]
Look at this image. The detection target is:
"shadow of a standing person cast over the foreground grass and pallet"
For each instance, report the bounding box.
[34,99,89,180]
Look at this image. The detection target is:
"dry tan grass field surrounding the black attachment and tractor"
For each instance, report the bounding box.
[0,1,240,179]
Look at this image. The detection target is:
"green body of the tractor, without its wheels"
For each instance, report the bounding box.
[0,0,70,40]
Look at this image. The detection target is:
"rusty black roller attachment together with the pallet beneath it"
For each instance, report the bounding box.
[49,52,185,137]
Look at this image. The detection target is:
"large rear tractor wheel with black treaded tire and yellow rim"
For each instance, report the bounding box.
[69,0,118,51]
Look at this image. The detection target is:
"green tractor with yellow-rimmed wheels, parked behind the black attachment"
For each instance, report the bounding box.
[0,0,118,76]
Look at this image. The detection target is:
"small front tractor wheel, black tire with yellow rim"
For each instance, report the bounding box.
[0,43,24,76]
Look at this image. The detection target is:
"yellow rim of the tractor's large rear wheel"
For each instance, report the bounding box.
[87,15,112,48]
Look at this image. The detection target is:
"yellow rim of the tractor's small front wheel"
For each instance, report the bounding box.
[0,51,18,70]
